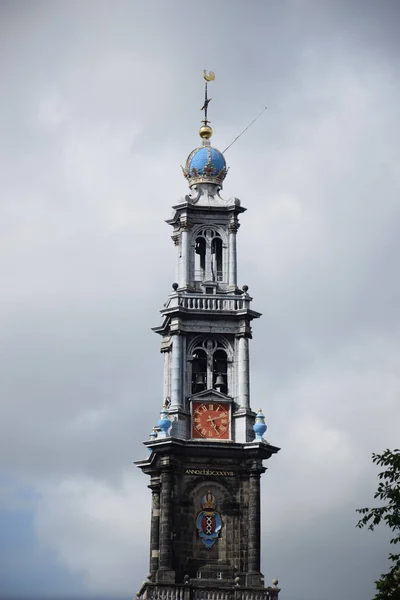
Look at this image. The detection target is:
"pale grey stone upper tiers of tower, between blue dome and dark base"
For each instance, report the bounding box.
[153,184,261,443]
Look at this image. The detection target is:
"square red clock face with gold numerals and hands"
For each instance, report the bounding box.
[192,401,229,440]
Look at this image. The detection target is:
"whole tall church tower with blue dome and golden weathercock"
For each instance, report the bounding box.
[135,72,279,600]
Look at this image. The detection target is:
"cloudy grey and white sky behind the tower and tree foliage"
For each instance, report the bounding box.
[0,0,400,600]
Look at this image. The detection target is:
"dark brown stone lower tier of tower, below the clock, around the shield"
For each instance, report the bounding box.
[136,438,279,598]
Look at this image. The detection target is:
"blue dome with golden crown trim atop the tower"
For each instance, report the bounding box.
[183,142,227,187]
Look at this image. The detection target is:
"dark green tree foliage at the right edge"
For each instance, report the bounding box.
[357,449,400,600]
